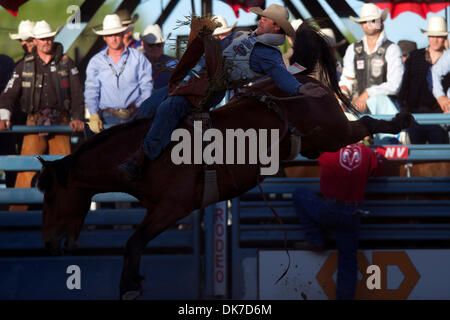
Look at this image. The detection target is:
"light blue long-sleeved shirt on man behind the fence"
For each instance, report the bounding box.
[84,48,153,114]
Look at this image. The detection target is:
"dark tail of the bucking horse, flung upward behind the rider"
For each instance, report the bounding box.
[290,21,359,114]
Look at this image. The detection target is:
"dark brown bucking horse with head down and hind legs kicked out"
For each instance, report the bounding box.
[38,23,413,299]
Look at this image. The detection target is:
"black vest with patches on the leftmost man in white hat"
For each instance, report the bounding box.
[20,43,70,113]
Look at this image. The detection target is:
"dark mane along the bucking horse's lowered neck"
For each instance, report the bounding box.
[37,118,150,192]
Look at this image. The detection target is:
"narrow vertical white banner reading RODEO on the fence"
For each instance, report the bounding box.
[213,201,228,297]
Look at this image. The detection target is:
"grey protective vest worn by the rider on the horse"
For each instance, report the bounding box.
[222,32,285,87]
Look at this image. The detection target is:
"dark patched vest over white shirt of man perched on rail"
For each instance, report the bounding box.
[354,40,392,95]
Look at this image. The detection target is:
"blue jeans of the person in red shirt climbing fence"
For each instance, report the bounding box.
[293,189,359,300]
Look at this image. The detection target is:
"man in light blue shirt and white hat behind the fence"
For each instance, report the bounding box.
[84,14,153,133]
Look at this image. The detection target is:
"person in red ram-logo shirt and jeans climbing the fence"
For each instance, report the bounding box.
[293,114,383,300]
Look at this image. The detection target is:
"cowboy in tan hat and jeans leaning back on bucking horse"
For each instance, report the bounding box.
[119,4,326,181]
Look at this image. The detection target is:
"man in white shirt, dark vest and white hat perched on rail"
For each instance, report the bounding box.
[340,3,403,143]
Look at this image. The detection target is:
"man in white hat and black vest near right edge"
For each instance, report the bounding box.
[399,17,449,144]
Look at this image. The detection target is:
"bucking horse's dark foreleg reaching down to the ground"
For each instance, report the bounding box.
[120,200,189,300]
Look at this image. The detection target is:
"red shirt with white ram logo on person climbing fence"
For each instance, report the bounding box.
[319,143,383,201]
